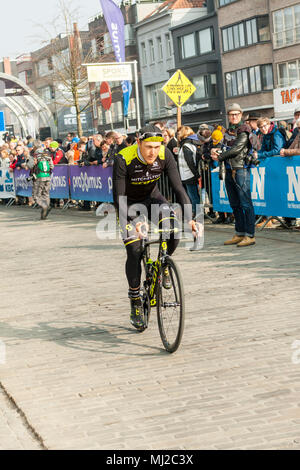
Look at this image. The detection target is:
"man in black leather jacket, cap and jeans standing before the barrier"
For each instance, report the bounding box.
[211,103,255,247]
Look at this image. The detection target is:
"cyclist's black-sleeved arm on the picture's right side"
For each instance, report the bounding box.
[165,149,193,222]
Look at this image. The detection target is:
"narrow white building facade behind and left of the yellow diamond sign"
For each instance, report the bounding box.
[136,0,207,123]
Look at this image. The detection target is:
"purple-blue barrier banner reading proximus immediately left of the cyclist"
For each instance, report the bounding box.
[69,165,113,202]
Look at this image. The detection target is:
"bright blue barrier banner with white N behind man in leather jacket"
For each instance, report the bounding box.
[211,156,300,218]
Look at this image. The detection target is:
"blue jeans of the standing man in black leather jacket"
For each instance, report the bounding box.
[225,168,255,237]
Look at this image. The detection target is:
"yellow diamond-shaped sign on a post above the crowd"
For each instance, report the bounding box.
[163,70,196,107]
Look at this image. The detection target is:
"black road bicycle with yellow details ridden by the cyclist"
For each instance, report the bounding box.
[141,228,185,353]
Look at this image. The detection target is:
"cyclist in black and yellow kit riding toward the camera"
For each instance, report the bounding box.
[113,125,196,329]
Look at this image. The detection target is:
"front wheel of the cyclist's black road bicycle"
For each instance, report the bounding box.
[157,258,185,353]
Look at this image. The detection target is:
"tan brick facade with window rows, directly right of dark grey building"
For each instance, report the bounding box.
[216,0,274,116]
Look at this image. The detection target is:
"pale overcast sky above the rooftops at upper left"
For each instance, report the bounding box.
[0,0,109,59]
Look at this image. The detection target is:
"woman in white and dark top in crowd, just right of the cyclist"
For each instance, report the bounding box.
[177,126,200,217]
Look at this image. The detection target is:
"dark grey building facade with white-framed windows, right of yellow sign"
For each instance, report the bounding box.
[171,0,225,130]
